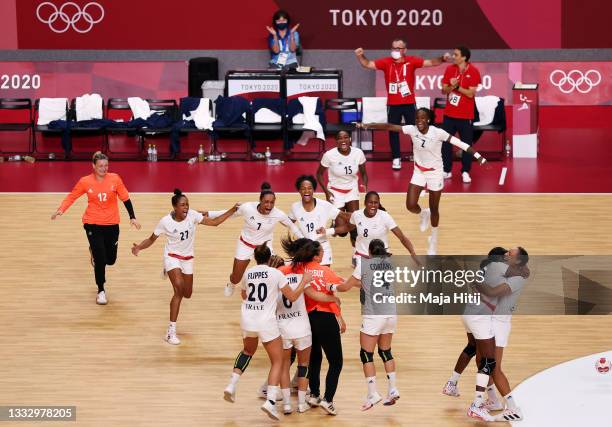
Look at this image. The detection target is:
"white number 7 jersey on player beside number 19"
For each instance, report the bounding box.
[234,202,301,245]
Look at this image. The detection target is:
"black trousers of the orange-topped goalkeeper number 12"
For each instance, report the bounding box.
[83,224,119,292]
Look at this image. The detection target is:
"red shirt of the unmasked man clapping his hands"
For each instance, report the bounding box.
[442,63,480,120]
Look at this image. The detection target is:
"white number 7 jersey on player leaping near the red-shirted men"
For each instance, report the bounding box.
[402,125,450,170]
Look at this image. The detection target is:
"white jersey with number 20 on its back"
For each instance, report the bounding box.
[240,265,288,332]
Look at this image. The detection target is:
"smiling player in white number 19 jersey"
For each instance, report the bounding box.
[289,175,350,265]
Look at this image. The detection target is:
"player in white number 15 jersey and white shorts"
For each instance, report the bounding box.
[317,131,368,254]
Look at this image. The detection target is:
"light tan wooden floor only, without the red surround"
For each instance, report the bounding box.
[0,194,612,426]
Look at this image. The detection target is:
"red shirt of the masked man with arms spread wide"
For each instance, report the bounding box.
[374,56,425,105]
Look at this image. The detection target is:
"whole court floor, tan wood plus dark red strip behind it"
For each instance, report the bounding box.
[0,108,612,426]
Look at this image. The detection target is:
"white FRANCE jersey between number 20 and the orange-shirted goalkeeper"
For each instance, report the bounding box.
[276,266,312,339]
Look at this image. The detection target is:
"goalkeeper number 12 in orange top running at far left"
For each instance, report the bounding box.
[51,151,140,305]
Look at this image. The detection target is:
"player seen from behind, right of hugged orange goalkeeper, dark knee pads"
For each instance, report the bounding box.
[329,239,400,411]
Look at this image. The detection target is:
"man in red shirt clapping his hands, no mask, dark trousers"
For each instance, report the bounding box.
[442,46,480,183]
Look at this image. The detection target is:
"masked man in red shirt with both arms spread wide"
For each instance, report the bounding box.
[355,39,450,170]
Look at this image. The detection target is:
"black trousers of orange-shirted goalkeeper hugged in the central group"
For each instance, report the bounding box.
[308,310,342,402]
